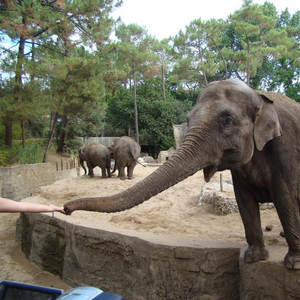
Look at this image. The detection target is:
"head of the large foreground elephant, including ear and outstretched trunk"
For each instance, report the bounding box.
[64,79,281,214]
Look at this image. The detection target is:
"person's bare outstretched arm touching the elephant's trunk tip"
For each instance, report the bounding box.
[0,198,65,214]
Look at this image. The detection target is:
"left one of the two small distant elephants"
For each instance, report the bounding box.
[78,143,111,178]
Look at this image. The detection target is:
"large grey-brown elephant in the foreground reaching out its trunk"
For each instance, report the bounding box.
[64,79,300,269]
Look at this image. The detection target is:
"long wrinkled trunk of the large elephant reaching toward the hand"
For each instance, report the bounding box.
[64,132,212,214]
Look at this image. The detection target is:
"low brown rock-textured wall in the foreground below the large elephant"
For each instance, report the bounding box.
[17,214,300,300]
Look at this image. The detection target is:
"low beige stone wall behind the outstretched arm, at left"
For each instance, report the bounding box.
[0,163,80,201]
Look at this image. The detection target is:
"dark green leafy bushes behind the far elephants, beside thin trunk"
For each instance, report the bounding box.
[107,78,192,150]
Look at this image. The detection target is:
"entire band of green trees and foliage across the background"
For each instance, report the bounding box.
[0,0,300,157]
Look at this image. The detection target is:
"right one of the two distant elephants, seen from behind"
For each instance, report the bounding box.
[110,136,141,180]
